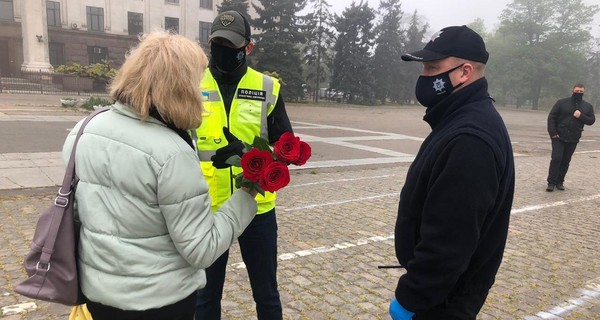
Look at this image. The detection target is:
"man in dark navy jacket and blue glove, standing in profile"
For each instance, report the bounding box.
[390,26,515,320]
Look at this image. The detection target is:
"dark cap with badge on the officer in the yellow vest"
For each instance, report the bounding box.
[210,10,251,47]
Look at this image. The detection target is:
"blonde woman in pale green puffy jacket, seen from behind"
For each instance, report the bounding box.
[63,32,257,320]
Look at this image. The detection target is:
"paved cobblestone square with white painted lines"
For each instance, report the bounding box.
[0,105,600,319]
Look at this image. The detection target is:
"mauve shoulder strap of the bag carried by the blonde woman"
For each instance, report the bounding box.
[37,108,110,269]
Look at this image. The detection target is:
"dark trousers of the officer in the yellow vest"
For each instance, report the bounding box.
[196,209,282,320]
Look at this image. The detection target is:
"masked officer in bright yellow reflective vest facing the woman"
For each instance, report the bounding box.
[196,11,293,320]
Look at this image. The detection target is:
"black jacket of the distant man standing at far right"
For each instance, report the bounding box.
[548,98,596,143]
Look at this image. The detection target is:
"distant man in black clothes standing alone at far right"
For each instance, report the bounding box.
[546,83,596,192]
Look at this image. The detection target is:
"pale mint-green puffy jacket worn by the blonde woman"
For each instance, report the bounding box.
[63,103,257,310]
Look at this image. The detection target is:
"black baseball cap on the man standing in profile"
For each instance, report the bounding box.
[402,26,490,64]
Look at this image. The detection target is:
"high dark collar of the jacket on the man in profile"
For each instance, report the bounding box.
[423,78,492,129]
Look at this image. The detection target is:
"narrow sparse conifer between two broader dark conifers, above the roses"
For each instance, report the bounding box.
[302,0,335,102]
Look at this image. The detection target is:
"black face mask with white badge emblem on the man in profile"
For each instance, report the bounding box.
[415,63,464,108]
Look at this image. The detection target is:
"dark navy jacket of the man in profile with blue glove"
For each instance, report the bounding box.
[395,78,515,312]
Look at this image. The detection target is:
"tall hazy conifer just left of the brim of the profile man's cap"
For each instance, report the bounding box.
[373,0,406,104]
